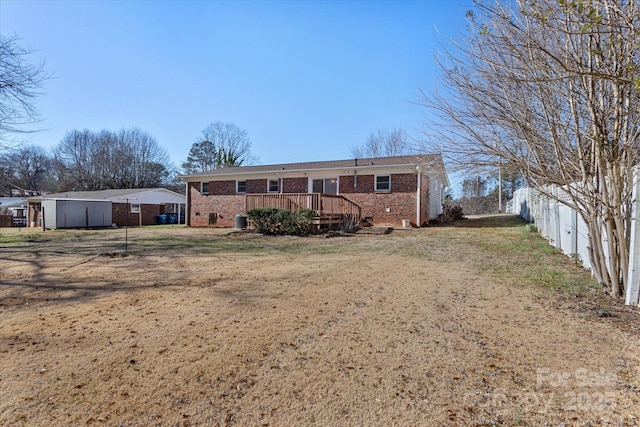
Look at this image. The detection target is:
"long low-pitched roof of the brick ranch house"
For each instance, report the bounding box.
[180,154,448,185]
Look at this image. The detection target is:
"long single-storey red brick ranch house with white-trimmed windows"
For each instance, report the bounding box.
[181,154,449,227]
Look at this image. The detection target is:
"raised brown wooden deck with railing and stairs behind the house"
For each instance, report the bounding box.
[245,193,361,229]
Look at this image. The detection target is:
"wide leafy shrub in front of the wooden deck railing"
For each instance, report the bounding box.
[247,208,315,236]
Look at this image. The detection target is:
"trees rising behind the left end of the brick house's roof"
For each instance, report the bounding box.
[182,122,256,173]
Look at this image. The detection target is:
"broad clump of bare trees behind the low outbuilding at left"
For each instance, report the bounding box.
[55,128,173,190]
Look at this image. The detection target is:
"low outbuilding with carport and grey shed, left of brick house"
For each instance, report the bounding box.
[28,188,185,229]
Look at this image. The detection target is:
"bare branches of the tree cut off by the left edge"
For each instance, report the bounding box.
[0,35,49,148]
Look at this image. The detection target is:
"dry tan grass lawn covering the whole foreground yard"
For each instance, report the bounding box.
[0,216,640,426]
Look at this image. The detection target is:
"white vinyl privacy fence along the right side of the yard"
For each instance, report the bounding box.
[506,186,640,304]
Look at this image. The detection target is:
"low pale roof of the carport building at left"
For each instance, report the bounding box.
[29,188,185,204]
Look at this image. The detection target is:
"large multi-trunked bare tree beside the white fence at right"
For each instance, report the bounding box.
[423,0,640,296]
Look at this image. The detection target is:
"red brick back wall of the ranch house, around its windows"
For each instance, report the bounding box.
[188,173,429,227]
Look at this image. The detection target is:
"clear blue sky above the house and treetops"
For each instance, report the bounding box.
[0,0,471,169]
